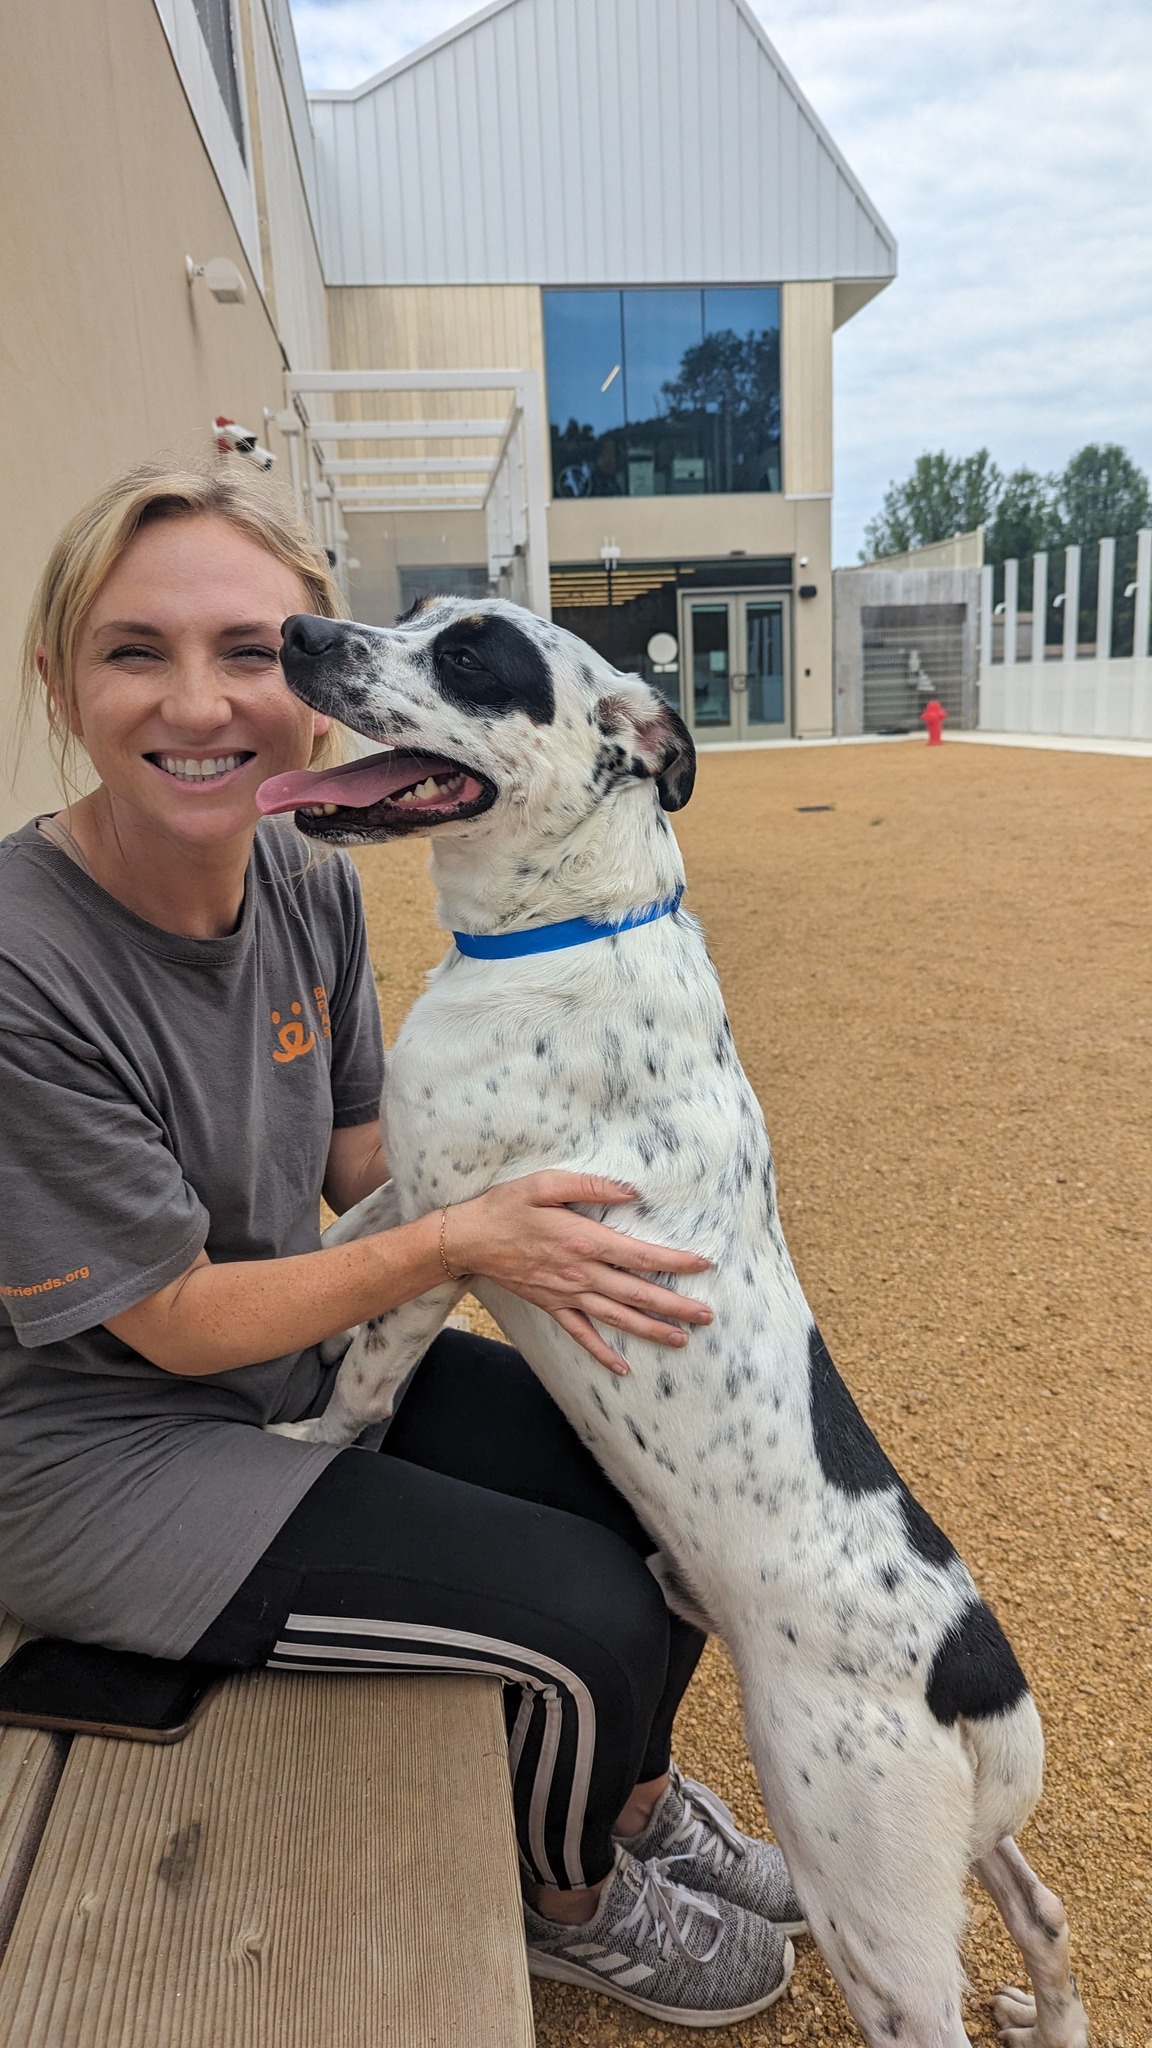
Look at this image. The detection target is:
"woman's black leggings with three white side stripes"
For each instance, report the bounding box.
[191,1331,705,1886]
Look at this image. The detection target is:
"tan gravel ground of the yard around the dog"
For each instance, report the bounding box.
[357,743,1152,2048]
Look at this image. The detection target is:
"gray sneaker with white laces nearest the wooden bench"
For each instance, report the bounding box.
[525,1847,795,2028]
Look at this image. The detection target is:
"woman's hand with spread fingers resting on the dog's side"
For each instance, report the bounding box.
[445,1171,711,1374]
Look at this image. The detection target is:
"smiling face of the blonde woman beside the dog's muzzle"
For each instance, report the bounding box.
[74,514,330,846]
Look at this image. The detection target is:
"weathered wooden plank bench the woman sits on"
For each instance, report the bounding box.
[0,1612,533,2048]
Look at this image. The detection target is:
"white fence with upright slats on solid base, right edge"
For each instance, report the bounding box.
[978,530,1152,739]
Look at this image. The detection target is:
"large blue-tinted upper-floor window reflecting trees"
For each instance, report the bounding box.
[543,285,781,498]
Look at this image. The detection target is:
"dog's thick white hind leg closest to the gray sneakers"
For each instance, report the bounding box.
[740,1679,972,2048]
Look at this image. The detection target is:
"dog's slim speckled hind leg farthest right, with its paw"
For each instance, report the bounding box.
[976,1835,1088,2048]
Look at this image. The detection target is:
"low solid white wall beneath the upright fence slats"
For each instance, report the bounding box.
[980,655,1152,739]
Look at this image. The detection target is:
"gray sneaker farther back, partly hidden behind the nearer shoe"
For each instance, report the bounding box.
[623,1763,806,1933]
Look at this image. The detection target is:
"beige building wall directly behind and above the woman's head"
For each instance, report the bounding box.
[0,0,324,829]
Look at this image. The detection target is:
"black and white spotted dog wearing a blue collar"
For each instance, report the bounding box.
[260,598,1088,2048]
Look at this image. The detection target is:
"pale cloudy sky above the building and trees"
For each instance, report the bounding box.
[291,0,1152,561]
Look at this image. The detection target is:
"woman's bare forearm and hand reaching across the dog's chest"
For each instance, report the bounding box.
[105,1174,711,1378]
